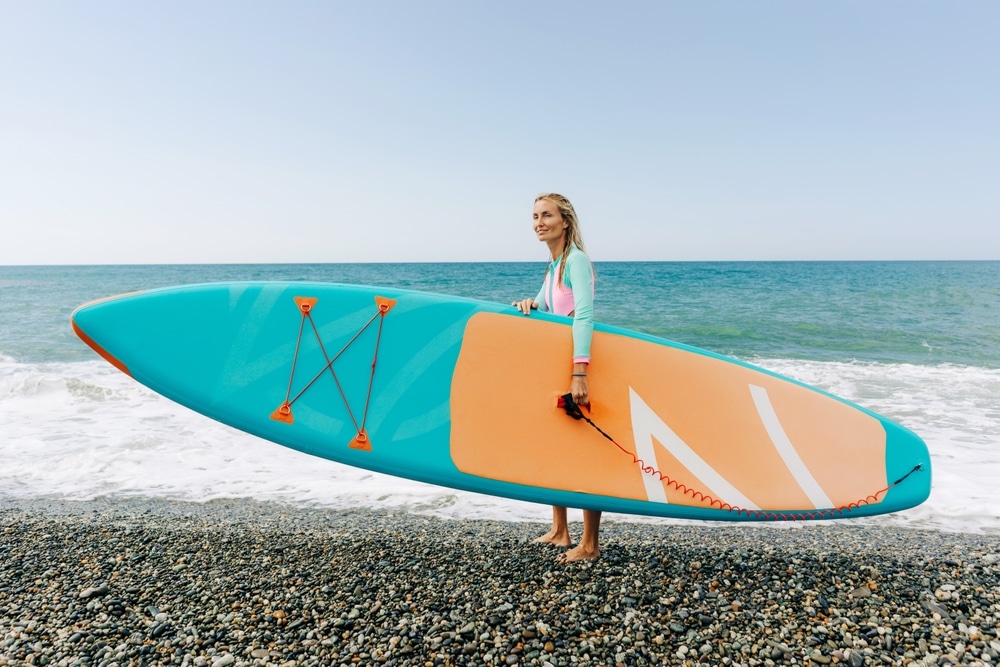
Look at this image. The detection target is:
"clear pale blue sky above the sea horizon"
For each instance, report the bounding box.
[0,0,1000,265]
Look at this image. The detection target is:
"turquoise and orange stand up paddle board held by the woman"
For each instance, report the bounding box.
[72,282,931,521]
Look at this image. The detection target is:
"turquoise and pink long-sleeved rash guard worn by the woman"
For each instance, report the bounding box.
[535,246,594,364]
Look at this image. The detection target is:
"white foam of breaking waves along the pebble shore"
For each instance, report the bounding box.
[0,359,1000,532]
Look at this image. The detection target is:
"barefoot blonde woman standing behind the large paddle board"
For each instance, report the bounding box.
[512,192,601,563]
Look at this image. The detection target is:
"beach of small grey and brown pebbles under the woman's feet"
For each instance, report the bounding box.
[0,498,1000,667]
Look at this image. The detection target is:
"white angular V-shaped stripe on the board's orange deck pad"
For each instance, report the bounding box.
[628,387,760,510]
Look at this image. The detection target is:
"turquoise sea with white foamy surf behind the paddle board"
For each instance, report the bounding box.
[0,261,1000,533]
